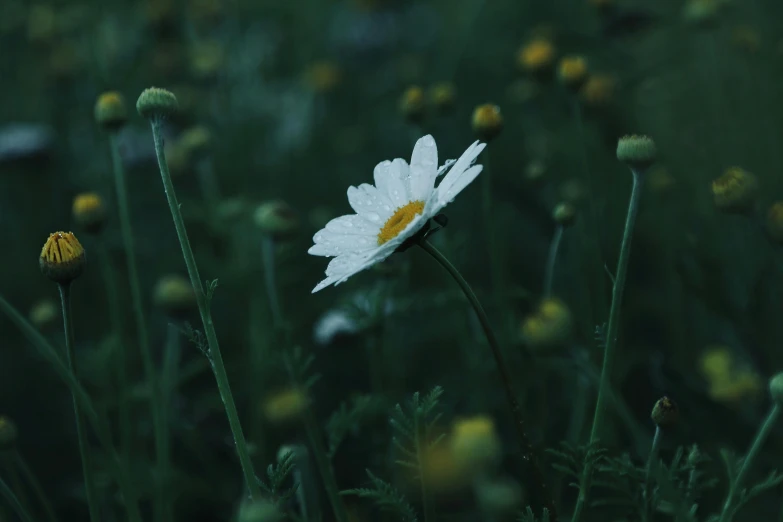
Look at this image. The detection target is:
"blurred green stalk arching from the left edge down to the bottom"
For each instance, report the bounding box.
[0,296,142,522]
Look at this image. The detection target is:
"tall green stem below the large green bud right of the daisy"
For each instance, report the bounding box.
[571,169,644,522]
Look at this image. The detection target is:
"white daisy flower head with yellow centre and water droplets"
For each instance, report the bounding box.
[308,135,486,293]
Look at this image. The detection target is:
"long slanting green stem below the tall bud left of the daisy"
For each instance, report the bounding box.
[150,118,261,500]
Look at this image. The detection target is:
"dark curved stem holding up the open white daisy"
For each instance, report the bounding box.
[419,239,557,522]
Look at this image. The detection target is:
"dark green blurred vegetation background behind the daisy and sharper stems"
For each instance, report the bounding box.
[0,0,783,522]
